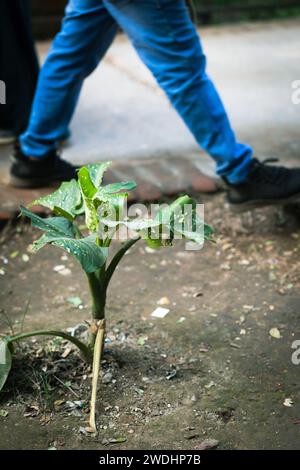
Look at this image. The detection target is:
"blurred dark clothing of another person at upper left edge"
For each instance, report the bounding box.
[0,0,39,135]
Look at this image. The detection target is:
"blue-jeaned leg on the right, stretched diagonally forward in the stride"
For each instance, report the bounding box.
[104,0,252,183]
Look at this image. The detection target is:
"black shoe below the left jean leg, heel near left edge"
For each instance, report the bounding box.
[10,146,76,188]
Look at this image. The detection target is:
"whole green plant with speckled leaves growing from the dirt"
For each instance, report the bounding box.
[0,162,212,432]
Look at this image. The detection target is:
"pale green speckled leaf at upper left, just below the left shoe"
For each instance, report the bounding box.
[28,180,82,220]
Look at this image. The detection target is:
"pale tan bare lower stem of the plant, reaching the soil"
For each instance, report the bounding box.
[89,320,105,432]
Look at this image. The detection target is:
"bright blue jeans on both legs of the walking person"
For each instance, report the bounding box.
[21,0,252,183]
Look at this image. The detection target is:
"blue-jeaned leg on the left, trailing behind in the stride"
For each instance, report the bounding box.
[20,0,118,157]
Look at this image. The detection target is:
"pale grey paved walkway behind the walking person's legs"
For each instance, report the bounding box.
[0,19,300,215]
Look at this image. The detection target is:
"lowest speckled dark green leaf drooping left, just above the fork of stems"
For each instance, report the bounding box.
[33,234,108,273]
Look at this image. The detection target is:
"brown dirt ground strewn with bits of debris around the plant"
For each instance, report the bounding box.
[0,194,300,450]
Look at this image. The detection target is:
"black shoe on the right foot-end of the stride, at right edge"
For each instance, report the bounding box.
[223,159,300,212]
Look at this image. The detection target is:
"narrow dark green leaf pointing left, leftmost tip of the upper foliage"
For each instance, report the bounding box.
[21,206,75,238]
